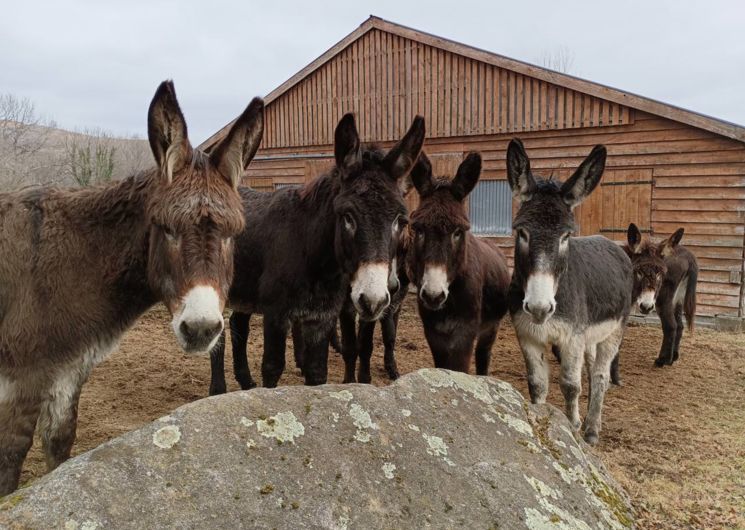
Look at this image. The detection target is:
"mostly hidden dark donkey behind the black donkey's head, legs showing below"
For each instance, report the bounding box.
[338,225,410,383]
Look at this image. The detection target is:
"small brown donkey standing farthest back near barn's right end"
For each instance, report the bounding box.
[624,223,698,367]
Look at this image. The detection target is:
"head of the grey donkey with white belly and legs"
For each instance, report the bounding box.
[507,139,606,324]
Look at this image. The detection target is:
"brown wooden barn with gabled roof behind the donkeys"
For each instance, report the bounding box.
[202,17,745,324]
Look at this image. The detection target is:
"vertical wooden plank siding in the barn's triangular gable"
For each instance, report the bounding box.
[262,29,633,149]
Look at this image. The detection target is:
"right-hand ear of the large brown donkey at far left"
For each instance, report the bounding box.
[210,98,264,188]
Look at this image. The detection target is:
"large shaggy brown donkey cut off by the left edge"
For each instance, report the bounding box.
[0,81,263,495]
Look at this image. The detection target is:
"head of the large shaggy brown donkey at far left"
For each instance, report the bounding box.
[146,81,264,353]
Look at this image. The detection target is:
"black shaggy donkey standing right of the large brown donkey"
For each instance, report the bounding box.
[210,114,424,393]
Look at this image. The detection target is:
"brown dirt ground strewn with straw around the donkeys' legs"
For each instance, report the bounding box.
[22,297,745,529]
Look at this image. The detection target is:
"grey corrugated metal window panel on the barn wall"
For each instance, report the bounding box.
[468,180,512,236]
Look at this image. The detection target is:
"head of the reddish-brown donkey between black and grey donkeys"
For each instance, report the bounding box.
[408,152,481,310]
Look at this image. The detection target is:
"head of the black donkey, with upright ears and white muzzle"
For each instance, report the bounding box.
[334,114,424,320]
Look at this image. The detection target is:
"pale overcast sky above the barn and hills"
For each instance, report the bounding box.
[0,0,745,145]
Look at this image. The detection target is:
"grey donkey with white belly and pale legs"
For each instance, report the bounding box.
[507,139,632,445]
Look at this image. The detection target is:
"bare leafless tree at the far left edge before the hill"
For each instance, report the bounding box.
[0,94,58,189]
